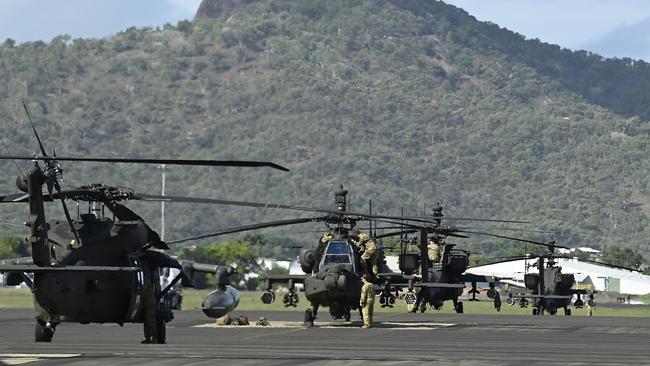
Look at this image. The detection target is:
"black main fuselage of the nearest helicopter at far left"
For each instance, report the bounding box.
[32,215,160,324]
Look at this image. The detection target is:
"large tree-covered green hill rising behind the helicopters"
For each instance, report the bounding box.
[0,0,650,256]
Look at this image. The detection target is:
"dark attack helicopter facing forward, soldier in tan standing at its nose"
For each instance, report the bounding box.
[168,189,390,325]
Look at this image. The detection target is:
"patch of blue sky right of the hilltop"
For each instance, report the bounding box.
[445,0,650,61]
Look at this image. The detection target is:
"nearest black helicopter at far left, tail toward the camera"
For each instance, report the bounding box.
[0,107,288,343]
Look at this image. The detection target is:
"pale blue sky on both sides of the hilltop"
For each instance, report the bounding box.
[0,0,650,61]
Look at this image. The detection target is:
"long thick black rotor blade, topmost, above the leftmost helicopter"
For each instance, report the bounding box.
[0,155,289,172]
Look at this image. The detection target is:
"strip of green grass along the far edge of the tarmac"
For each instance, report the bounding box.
[0,288,650,317]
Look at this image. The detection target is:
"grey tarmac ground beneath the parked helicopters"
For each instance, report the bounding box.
[0,309,650,366]
